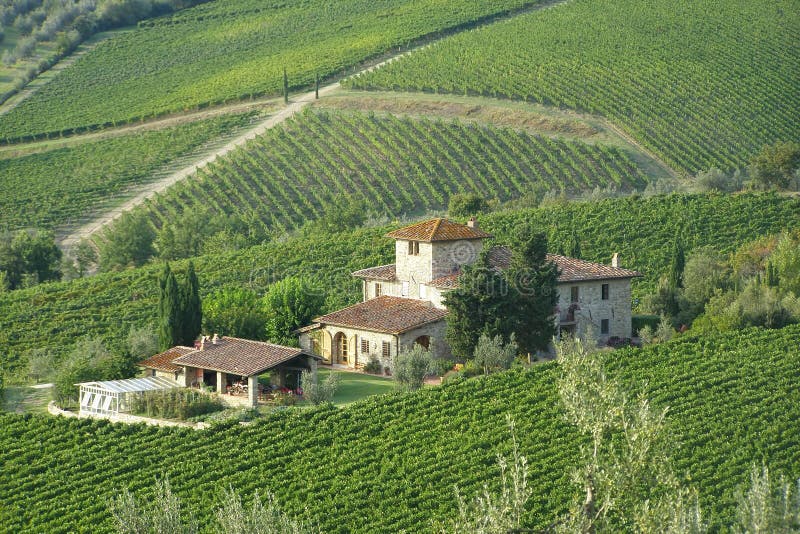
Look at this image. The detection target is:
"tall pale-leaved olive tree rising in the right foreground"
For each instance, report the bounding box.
[556,340,705,532]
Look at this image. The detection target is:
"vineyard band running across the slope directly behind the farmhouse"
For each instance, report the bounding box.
[0,195,800,372]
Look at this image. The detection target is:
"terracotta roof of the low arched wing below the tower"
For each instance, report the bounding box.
[314,295,447,334]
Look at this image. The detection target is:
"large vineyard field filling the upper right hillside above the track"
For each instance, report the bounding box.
[345,0,800,174]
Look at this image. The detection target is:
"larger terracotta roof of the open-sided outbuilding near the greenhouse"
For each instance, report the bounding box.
[173,336,318,376]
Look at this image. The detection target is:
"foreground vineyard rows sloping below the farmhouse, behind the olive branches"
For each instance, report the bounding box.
[0,326,800,533]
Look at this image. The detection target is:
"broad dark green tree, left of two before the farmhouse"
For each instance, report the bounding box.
[444,253,514,359]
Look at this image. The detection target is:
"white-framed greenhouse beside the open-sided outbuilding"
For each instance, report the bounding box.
[75,376,179,415]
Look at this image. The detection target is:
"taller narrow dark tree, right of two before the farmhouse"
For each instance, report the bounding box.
[505,225,558,354]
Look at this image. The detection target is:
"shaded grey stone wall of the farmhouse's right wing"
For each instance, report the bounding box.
[558,279,631,343]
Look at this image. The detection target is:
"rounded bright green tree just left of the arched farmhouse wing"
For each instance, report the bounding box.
[264,276,325,345]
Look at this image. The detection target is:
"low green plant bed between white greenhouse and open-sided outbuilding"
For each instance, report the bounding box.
[129,388,223,420]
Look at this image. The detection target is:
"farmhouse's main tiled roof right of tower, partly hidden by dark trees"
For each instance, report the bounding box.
[429,247,641,289]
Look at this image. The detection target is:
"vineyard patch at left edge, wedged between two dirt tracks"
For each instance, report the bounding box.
[0,115,249,229]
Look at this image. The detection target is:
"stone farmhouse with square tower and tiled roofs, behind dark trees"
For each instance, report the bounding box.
[298,218,640,367]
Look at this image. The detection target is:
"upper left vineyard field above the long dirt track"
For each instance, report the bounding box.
[0,0,536,137]
